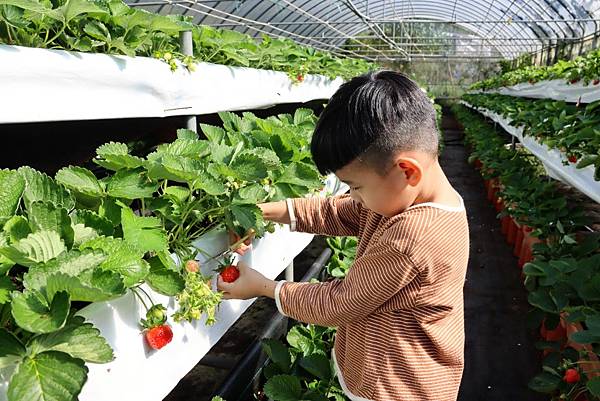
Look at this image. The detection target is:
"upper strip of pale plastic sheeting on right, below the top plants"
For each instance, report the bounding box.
[471,79,600,103]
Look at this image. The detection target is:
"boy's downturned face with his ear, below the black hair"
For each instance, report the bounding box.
[335,152,423,217]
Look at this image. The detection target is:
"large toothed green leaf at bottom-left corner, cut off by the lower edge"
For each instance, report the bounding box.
[7,351,88,401]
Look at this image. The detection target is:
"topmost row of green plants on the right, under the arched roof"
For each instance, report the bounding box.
[471,50,600,90]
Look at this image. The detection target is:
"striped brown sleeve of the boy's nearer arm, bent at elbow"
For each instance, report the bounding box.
[275,243,419,327]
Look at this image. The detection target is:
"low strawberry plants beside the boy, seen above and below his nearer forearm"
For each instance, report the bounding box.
[262,237,357,401]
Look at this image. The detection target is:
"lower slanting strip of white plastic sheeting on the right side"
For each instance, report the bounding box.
[461,101,600,203]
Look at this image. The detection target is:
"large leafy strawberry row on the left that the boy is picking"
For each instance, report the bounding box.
[0,109,323,401]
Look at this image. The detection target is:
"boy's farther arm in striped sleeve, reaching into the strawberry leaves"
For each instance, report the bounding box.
[259,195,362,236]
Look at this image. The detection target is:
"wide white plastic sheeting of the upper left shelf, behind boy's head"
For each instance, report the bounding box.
[0,45,343,124]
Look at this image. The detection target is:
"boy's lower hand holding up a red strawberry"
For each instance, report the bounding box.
[217,262,277,299]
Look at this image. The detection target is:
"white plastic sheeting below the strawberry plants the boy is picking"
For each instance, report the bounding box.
[0,175,348,401]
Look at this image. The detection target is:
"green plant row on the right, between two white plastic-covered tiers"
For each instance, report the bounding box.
[463,94,600,181]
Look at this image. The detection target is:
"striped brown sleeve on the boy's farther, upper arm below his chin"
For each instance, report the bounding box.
[290,195,362,236]
